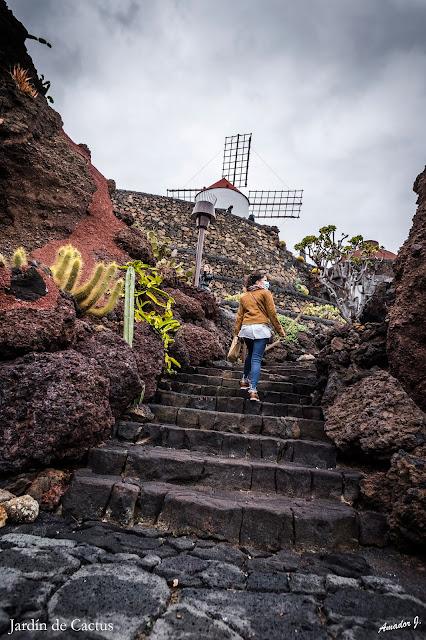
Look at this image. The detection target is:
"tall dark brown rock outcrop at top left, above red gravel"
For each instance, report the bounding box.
[0,2,95,253]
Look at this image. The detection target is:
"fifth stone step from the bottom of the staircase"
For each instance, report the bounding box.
[154,390,323,420]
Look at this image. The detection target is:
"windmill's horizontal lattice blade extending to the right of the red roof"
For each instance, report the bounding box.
[249,189,303,218]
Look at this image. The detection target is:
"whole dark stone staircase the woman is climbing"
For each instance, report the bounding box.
[63,363,386,550]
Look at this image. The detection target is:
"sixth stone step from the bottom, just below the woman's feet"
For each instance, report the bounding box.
[159,379,312,405]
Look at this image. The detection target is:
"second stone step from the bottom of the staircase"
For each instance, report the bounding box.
[88,442,362,504]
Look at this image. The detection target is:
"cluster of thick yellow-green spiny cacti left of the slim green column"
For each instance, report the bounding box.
[51,244,124,317]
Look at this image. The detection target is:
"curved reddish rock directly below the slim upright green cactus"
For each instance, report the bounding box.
[73,320,142,417]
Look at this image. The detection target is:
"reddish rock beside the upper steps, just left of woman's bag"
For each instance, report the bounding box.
[171,323,225,366]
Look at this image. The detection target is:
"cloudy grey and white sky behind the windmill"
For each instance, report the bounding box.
[8,0,426,252]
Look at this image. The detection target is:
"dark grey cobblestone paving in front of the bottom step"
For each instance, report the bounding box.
[0,514,426,640]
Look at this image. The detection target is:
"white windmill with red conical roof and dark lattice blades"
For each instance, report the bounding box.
[167,133,303,220]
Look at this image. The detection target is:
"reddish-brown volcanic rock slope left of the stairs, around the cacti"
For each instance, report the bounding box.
[0,0,223,484]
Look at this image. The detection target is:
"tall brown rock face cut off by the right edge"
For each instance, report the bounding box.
[387,162,426,410]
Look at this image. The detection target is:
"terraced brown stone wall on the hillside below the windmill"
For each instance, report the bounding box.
[112,189,332,311]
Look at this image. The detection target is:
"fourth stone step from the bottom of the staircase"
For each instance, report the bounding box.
[149,404,329,442]
